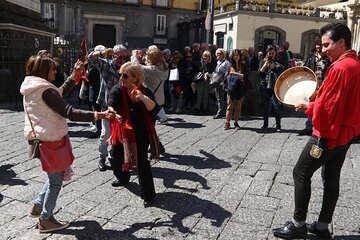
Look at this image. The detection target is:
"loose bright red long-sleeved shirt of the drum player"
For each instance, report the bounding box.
[305,50,360,149]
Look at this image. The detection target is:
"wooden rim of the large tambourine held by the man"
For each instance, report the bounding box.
[274,66,318,107]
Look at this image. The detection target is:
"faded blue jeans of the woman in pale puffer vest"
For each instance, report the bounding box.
[35,172,63,219]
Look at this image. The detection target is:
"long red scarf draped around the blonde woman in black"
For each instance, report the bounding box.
[109,86,160,171]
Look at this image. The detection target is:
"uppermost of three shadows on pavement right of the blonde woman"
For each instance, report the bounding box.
[162,150,231,169]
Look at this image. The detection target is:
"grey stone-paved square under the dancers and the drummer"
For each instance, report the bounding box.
[0,102,360,240]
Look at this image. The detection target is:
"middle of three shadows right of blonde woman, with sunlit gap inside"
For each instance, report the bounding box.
[152,167,210,192]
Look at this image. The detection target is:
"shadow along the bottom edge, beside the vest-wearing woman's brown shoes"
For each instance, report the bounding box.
[54,220,156,240]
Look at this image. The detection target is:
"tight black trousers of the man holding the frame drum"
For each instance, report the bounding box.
[293,136,350,223]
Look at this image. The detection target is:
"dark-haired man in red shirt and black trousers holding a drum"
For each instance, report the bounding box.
[273,23,360,239]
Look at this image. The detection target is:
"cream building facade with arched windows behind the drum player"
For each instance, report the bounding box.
[214,5,346,58]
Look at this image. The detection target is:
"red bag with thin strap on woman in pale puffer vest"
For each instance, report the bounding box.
[25,107,75,173]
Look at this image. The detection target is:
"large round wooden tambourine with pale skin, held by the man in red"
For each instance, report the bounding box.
[274,66,318,107]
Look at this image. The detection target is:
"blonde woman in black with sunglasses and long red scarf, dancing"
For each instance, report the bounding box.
[108,62,160,207]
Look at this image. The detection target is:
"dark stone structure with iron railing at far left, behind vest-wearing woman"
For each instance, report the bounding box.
[0,0,55,103]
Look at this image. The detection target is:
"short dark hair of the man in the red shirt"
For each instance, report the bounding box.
[320,23,351,49]
